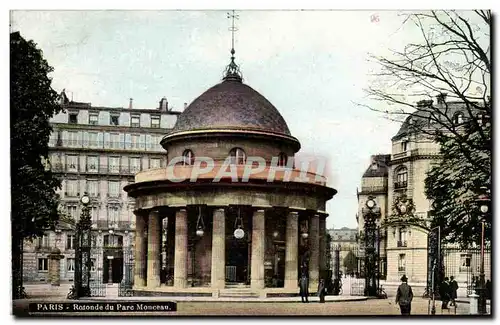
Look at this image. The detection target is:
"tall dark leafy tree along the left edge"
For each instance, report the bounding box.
[10,32,61,299]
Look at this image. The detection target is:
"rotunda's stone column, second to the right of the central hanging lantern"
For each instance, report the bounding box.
[285,211,299,290]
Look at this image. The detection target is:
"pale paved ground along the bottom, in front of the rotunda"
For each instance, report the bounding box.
[14,298,486,317]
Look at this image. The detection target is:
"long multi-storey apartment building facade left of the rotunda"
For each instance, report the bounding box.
[23,91,179,283]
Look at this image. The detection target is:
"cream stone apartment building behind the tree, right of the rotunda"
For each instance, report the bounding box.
[358,96,491,292]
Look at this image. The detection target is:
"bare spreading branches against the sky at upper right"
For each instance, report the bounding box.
[360,11,491,156]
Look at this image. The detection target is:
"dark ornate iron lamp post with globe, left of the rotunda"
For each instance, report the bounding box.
[73,192,92,299]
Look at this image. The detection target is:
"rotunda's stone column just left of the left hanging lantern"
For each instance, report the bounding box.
[174,209,188,288]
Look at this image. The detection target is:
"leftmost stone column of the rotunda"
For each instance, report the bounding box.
[134,214,148,287]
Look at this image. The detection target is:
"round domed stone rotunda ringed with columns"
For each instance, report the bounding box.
[125,58,336,297]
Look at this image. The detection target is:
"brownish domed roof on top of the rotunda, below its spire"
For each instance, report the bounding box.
[170,78,291,136]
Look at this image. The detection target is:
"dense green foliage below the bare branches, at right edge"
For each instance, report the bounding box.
[425,115,492,247]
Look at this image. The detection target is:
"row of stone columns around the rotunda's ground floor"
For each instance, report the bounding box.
[134,207,326,292]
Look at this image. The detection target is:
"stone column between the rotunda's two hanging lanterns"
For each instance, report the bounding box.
[210,209,226,289]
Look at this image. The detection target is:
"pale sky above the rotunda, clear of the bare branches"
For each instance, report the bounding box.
[11,11,446,228]
